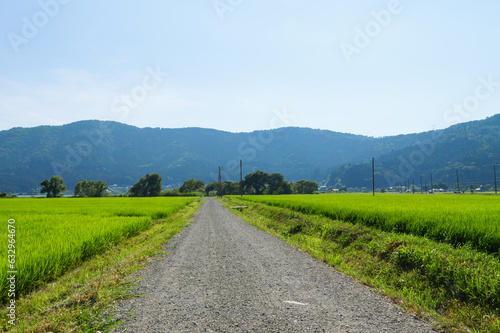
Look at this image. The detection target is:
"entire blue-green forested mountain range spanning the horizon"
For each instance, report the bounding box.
[0,115,500,194]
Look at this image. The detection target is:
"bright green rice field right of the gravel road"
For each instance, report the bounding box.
[238,194,500,253]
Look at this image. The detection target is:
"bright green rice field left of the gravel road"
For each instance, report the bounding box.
[0,197,194,301]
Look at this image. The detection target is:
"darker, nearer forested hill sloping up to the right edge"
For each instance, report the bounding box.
[328,115,500,188]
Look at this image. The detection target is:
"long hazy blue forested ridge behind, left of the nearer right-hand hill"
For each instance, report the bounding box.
[0,120,418,194]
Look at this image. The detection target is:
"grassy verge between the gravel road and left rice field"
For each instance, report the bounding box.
[0,201,201,333]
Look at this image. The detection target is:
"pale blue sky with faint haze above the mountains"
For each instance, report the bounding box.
[0,0,500,137]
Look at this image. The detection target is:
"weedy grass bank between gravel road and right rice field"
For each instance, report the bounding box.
[221,197,500,332]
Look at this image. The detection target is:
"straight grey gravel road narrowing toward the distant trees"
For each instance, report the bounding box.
[111,198,436,332]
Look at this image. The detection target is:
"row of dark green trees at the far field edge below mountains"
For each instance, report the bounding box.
[35,170,318,198]
